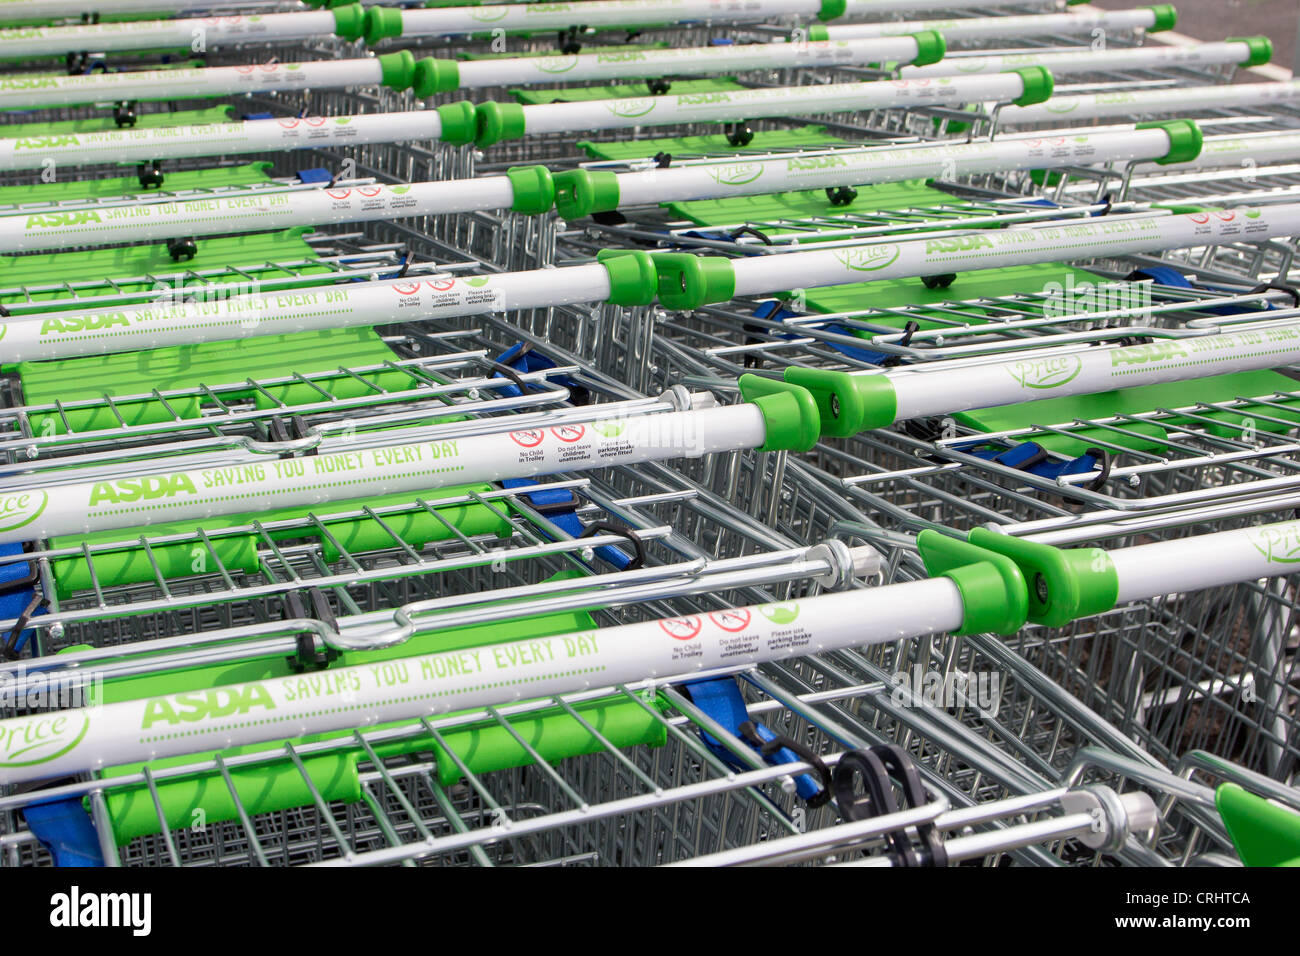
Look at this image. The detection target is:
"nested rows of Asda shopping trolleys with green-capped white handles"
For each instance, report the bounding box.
[0,0,1300,866]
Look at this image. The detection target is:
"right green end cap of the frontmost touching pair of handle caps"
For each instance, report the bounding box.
[966,528,1119,627]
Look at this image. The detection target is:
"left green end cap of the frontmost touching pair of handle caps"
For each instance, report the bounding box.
[917,528,1028,635]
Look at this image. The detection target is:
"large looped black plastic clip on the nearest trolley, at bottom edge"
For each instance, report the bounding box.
[833,744,948,866]
